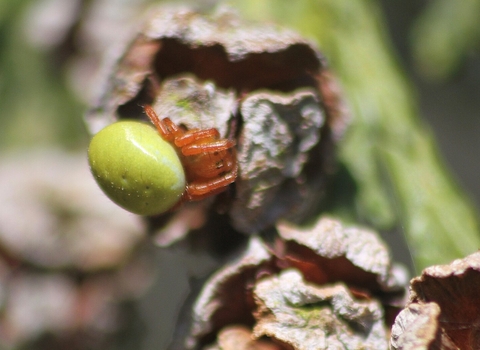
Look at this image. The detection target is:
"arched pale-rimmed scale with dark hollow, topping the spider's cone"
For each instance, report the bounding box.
[87,7,325,131]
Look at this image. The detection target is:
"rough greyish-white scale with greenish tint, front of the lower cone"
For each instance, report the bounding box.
[254,270,387,350]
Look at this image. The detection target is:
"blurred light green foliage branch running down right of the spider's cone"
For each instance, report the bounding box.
[231,0,480,268]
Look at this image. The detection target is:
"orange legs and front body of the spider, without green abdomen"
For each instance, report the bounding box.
[143,105,238,202]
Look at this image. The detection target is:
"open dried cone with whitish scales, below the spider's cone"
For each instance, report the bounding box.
[188,218,406,349]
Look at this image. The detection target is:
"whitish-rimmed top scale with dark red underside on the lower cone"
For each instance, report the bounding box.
[277,217,404,293]
